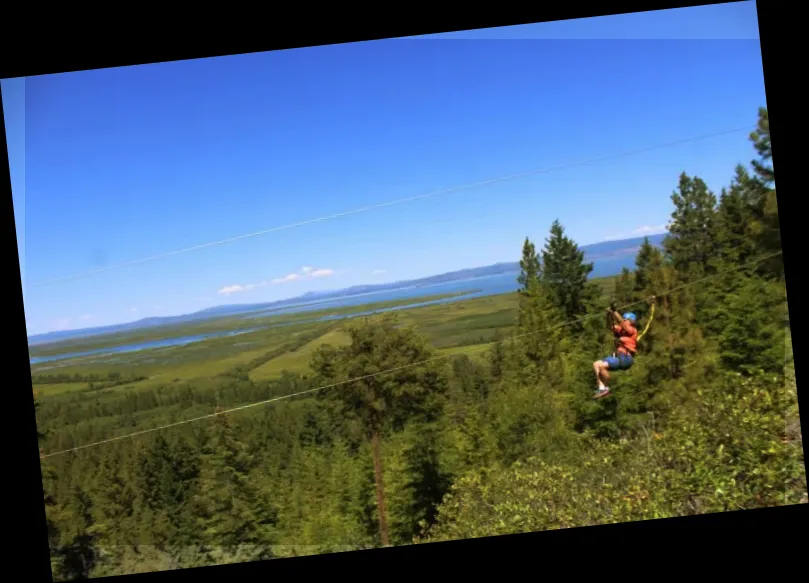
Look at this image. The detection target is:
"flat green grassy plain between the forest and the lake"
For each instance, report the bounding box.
[31,278,614,397]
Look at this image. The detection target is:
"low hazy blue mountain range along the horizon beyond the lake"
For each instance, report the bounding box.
[28,235,665,346]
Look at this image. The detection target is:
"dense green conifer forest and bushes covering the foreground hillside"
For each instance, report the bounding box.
[34,109,807,580]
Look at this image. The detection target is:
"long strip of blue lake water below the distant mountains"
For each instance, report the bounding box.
[30,255,635,364]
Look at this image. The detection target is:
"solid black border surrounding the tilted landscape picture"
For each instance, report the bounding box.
[0,0,809,581]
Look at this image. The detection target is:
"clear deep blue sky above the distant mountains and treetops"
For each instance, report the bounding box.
[2,2,765,334]
